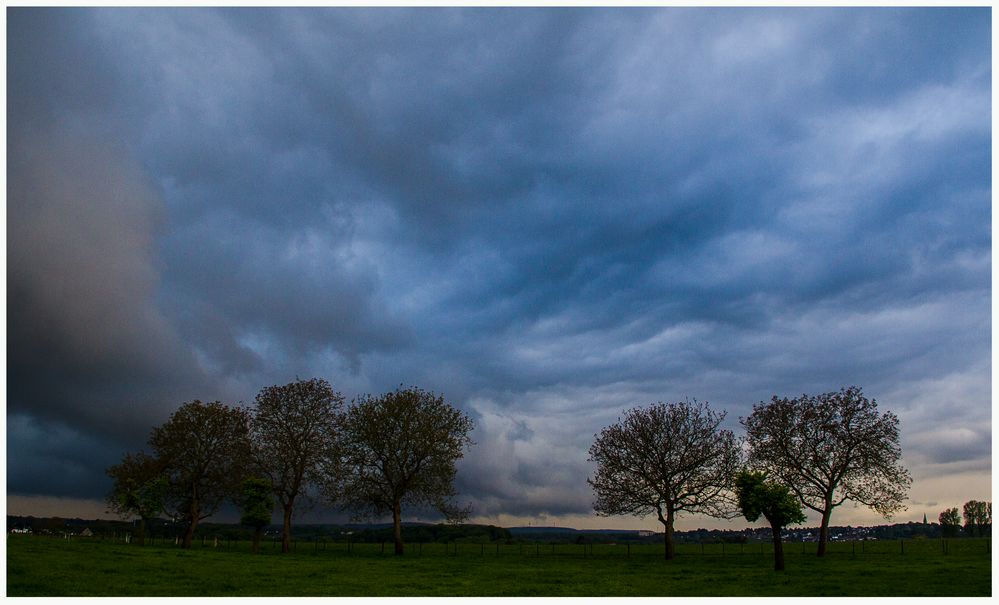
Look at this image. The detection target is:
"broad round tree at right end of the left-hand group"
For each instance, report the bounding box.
[327,387,473,555]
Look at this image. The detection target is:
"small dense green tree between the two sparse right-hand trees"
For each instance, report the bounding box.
[735,470,805,571]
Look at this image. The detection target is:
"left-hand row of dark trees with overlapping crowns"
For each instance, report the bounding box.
[107,379,473,554]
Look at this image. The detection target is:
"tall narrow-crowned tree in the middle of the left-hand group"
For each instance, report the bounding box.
[250,378,344,552]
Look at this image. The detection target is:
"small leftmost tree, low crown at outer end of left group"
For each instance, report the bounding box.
[107,452,169,546]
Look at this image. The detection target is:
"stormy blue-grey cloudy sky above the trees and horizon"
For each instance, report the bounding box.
[6,7,992,529]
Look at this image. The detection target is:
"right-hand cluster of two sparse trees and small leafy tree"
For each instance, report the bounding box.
[588,387,916,570]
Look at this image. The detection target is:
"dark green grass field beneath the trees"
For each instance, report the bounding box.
[7,536,992,596]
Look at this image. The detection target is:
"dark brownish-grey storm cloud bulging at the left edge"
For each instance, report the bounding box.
[7,125,211,438]
